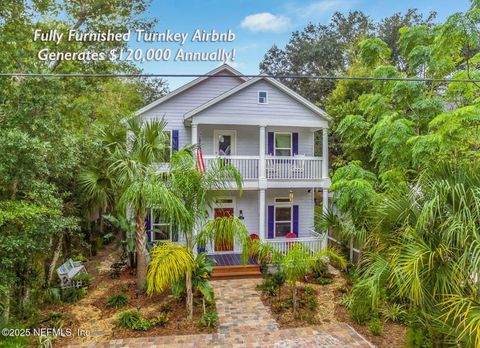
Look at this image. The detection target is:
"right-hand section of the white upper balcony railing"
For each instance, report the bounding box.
[265,156,322,180]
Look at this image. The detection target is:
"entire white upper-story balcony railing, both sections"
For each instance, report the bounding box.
[203,155,323,180]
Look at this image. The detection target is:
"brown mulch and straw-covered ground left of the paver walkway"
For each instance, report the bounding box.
[42,241,216,346]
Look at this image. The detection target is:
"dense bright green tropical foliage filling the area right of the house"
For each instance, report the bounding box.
[308,2,480,347]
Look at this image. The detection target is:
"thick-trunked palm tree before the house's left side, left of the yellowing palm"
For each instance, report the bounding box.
[109,119,190,290]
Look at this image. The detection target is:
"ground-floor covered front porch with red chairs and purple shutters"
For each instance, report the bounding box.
[201,188,326,255]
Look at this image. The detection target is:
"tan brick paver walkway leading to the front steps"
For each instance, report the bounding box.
[69,279,373,348]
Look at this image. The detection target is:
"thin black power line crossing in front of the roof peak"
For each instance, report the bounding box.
[0,73,480,83]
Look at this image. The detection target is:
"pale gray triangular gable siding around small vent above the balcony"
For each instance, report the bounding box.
[193,80,326,125]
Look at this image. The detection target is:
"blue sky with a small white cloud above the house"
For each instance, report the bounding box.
[131,0,470,89]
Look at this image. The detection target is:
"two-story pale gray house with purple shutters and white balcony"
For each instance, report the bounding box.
[137,65,330,268]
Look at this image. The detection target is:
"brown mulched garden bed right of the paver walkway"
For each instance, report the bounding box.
[261,267,406,348]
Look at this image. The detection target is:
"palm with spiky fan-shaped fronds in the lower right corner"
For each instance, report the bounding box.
[344,163,480,347]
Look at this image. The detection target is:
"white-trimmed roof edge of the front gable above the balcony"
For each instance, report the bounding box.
[184,76,332,121]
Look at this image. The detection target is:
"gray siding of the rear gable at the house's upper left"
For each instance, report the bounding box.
[142,71,242,147]
